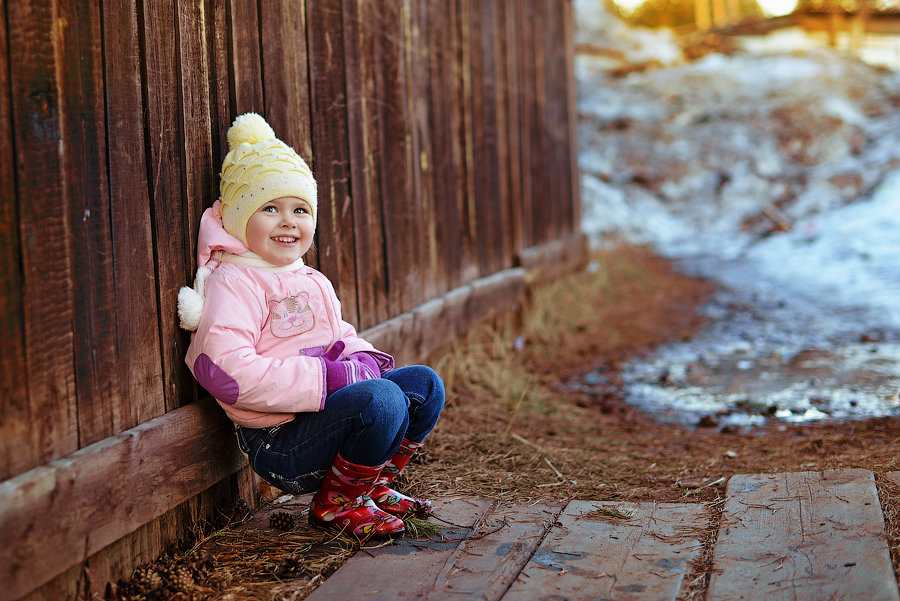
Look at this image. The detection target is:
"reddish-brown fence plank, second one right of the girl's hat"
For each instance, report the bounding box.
[342,0,390,330]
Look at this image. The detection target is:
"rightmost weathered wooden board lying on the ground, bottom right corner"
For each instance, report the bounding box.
[706,469,898,601]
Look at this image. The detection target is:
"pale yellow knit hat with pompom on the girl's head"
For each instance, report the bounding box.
[220,113,317,245]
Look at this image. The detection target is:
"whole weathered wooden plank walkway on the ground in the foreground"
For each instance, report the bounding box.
[308,469,900,601]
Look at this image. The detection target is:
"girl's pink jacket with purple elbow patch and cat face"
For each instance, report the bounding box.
[185,202,394,428]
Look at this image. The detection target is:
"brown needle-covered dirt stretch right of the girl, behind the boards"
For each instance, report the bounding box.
[417,246,900,501]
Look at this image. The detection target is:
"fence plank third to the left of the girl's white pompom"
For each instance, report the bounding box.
[56,3,124,447]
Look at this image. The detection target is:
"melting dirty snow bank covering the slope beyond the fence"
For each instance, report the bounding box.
[576,0,900,425]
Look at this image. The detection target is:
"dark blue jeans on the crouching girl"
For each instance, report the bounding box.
[237,365,444,493]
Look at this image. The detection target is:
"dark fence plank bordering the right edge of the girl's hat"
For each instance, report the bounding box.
[306,0,359,324]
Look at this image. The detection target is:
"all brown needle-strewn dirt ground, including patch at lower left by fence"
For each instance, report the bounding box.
[110,244,900,600]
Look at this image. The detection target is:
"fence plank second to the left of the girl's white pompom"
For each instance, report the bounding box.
[103,0,165,431]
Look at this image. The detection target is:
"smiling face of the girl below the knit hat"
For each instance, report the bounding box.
[247,196,316,265]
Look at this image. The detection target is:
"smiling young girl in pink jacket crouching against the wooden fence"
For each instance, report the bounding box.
[178,113,444,537]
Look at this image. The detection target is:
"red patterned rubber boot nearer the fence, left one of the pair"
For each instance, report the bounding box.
[309,455,405,539]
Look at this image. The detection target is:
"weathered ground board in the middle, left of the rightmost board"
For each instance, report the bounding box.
[503,501,707,601]
